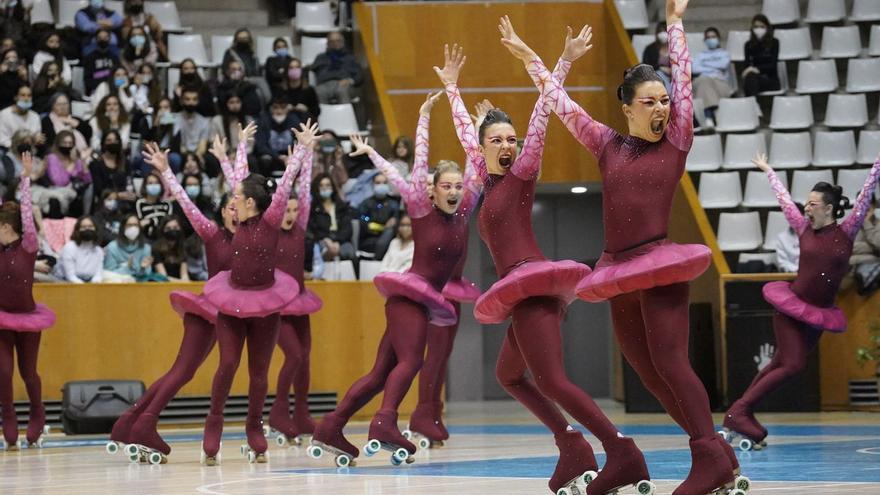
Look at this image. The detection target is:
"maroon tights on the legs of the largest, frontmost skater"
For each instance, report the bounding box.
[611,283,715,439]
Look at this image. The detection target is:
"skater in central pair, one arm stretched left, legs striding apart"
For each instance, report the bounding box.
[309,93,480,465]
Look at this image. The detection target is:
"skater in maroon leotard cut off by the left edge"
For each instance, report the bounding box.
[0,153,55,450]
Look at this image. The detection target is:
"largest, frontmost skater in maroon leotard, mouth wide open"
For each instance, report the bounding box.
[502,0,747,495]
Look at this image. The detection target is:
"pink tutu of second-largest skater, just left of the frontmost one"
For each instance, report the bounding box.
[474,260,590,323]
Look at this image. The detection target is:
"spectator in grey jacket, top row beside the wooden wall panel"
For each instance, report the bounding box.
[311,31,364,103]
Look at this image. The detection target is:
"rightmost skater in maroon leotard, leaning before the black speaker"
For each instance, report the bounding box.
[724,155,880,449]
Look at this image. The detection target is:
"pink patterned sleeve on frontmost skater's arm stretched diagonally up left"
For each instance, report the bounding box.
[527,59,615,158]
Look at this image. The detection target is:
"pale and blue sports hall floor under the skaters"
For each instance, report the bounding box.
[0,401,880,495]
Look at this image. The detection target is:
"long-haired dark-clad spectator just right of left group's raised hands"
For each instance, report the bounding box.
[308,174,356,261]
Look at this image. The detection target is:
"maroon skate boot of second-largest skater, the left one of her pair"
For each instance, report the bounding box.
[548,430,599,495]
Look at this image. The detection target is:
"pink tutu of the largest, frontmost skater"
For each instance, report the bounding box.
[577,239,712,302]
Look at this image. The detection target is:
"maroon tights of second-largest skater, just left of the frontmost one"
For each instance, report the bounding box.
[495,297,617,443]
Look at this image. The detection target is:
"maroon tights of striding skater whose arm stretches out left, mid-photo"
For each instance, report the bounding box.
[335,296,428,421]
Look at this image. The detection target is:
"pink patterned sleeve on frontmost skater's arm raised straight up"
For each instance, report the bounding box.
[666,23,694,152]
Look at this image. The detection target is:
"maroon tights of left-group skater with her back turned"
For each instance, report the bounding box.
[211,313,280,418]
